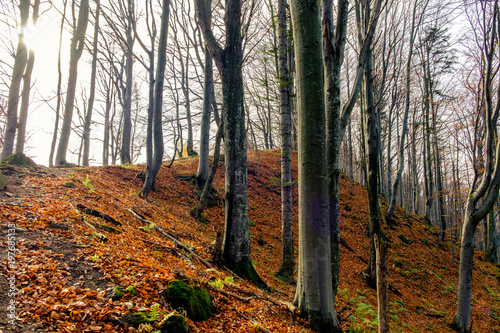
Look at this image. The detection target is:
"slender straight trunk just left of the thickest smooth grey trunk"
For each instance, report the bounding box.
[276,0,295,283]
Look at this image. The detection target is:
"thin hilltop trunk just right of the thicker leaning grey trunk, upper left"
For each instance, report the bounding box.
[82,0,101,166]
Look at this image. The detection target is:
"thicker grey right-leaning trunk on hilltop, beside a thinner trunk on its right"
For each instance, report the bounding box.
[55,0,89,165]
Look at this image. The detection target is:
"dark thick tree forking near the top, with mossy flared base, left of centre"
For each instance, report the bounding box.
[195,0,265,287]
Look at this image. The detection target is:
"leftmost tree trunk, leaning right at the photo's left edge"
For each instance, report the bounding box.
[0,0,30,161]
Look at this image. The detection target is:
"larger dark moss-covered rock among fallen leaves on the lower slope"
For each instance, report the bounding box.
[165,280,214,321]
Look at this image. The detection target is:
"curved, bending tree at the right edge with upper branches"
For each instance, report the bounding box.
[454,0,500,332]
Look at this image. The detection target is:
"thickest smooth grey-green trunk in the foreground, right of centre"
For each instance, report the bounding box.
[290,0,341,326]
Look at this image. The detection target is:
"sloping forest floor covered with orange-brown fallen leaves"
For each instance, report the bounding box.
[0,150,500,333]
